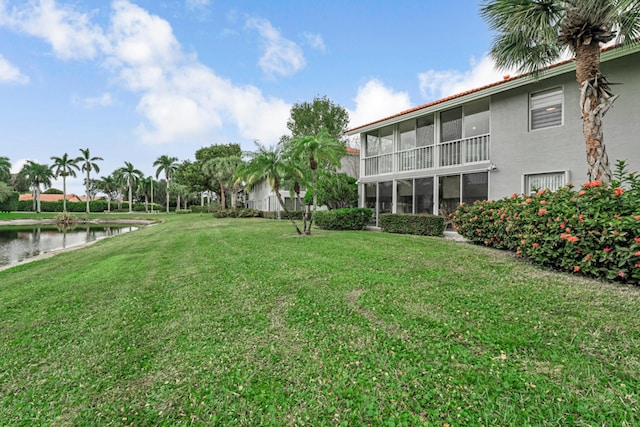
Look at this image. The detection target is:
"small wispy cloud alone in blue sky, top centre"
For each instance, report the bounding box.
[245,18,306,77]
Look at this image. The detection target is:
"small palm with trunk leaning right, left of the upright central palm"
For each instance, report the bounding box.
[236,141,302,234]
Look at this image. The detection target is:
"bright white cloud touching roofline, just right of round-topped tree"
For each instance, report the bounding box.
[349,79,411,128]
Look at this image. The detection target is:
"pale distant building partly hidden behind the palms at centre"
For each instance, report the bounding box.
[246,147,360,212]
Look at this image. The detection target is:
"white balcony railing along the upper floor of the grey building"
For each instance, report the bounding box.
[364,134,491,176]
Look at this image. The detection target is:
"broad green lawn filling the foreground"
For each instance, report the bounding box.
[0,215,640,426]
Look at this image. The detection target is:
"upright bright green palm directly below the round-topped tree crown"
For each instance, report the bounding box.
[287,129,347,234]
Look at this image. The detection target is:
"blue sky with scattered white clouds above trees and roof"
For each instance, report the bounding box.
[0,0,505,195]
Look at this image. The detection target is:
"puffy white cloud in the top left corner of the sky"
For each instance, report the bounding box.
[0,0,105,59]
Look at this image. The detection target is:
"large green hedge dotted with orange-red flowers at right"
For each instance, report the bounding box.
[452,162,640,285]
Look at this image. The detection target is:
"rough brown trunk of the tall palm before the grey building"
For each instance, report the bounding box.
[576,41,616,182]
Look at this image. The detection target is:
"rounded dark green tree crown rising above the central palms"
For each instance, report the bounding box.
[287,96,349,139]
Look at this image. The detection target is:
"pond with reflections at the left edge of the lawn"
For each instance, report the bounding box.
[0,224,139,269]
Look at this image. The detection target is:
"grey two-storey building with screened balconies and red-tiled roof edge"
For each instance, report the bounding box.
[346,45,640,224]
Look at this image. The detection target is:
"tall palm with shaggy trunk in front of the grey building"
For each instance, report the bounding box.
[481,0,640,182]
